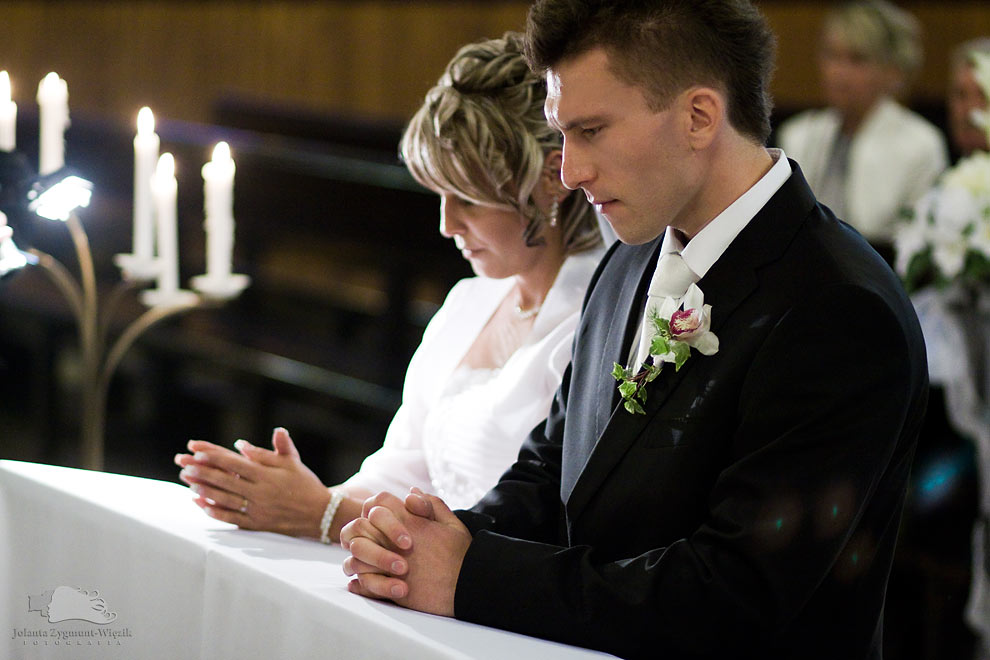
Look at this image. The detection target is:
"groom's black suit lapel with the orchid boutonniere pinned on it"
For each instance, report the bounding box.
[561,161,815,521]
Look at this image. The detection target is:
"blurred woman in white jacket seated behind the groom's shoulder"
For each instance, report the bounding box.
[778,0,948,257]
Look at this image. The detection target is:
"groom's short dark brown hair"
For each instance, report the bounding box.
[526,0,776,144]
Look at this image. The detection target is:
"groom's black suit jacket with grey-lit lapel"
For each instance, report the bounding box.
[455,162,928,660]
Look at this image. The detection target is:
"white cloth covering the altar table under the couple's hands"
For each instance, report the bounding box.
[0,460,611,660]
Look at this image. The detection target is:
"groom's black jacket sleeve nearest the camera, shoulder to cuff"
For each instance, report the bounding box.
[455,287,926,658]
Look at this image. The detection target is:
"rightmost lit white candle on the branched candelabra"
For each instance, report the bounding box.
[203,142,235,281]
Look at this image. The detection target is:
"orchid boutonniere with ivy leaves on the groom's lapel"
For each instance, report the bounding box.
[612,284,718,415]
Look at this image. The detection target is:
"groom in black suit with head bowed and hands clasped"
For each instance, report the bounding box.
[341,0,928,660]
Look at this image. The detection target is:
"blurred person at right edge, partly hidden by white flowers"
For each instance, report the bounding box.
[947,37,990,158]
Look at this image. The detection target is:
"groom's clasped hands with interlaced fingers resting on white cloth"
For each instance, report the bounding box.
[340,488,471,616]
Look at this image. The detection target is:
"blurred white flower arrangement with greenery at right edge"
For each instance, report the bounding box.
[894,52,990,291]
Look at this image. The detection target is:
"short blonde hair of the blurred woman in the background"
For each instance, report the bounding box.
[825,0,924,91]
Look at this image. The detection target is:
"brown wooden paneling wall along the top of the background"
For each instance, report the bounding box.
[0,0,990,126]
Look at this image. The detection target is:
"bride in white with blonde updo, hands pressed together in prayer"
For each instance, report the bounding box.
[176,33,603,542]
